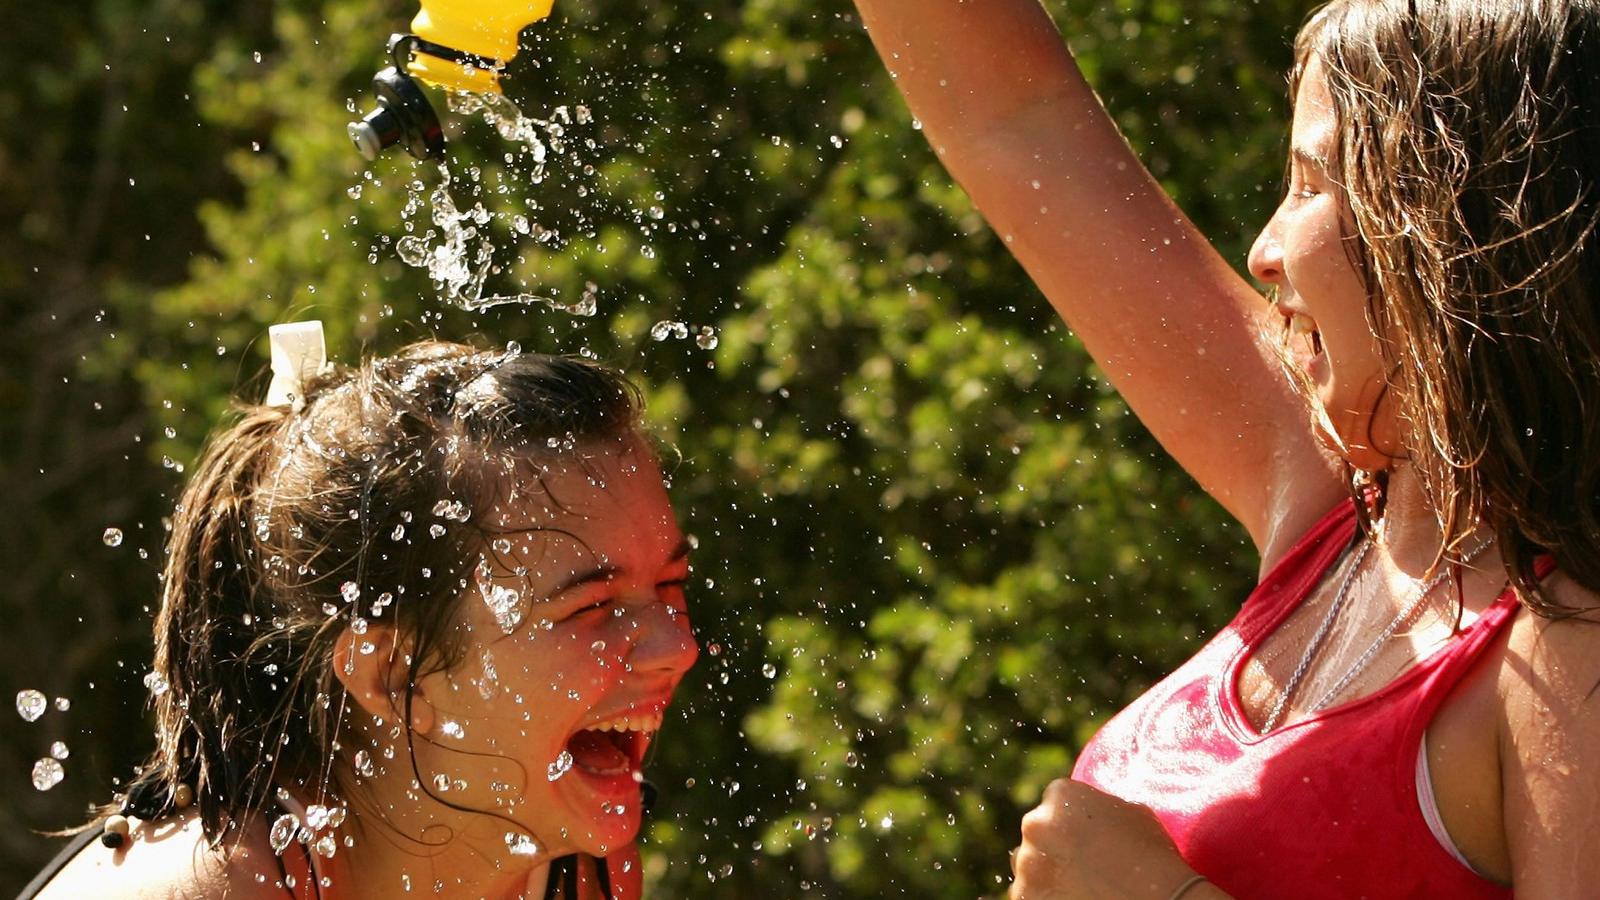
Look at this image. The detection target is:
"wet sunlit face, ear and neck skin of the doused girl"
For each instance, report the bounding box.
[331,432,698,897]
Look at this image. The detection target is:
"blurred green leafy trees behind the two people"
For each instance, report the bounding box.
[0,0,1307,897]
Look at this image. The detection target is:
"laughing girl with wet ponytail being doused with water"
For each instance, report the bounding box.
[24,338,698,900]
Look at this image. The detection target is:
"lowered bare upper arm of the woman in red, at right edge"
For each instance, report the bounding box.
[1499,573,1600,900]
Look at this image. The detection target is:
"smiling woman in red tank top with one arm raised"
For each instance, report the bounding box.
[858,0,1600,900]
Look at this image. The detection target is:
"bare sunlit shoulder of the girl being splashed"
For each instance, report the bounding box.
[38,812,288,900]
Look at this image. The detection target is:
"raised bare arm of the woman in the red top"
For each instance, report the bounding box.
[856,0,1342,562]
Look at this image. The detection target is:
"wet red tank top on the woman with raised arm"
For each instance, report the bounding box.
[1072,503,1518,900]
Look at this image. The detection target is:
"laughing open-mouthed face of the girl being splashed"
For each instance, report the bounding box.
[403,440,698,855]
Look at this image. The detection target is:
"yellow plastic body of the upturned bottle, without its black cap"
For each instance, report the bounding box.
[406,0,555,94]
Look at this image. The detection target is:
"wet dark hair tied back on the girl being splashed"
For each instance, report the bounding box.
[134,341,642,841]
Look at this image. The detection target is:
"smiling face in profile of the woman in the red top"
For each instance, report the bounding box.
[1250,58,1397,471]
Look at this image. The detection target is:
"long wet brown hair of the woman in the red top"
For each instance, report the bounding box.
[1291,0,1600,615]
